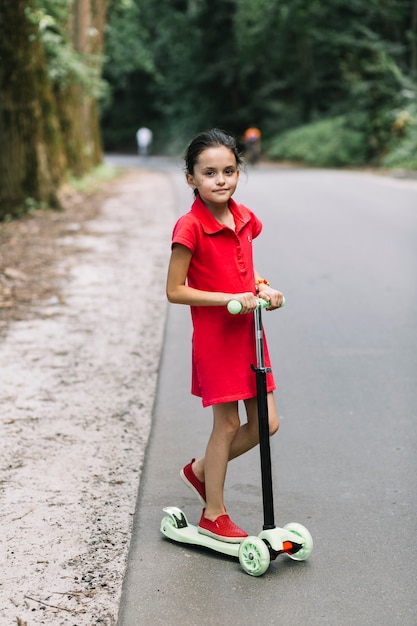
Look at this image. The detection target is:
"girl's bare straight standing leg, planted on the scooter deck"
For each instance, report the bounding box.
[202,402,240,521]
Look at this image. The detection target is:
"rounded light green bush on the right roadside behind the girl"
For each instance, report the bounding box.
[266,116,366,167]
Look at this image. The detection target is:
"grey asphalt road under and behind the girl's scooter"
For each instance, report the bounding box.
[114,160,417,626]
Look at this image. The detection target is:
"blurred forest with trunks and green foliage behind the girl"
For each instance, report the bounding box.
[0,0,417,220]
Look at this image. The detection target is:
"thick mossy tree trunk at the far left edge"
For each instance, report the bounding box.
[0,0,66,219]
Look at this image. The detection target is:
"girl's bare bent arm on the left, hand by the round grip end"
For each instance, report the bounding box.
[166,244,256,313]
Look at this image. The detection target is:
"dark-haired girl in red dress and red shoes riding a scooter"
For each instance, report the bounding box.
[167,129,283,543]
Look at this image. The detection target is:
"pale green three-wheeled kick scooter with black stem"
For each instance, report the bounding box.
[161,298,313,576]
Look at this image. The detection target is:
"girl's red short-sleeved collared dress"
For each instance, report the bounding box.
[172,196,275,406]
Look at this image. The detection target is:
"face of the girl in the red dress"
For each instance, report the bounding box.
[187,146,239,210]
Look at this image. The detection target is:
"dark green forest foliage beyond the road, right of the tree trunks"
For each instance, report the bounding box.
[99,0,417,164]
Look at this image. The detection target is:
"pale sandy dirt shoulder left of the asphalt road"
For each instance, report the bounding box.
[0,169,174,626]
